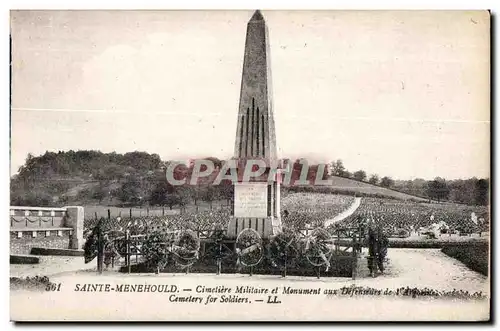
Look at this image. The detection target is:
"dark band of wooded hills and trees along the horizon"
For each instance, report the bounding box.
[10,150,489,208]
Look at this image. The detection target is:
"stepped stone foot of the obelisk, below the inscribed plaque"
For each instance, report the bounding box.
[227,216,282,239]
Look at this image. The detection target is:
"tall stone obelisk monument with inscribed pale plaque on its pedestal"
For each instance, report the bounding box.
[228,10,281,238]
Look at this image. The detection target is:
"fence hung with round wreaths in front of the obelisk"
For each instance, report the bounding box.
[87,218,364,278]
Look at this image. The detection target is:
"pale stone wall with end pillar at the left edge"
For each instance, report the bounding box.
[10,206,84,254]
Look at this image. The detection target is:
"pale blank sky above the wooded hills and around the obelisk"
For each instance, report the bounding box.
[11,11,490,179]
